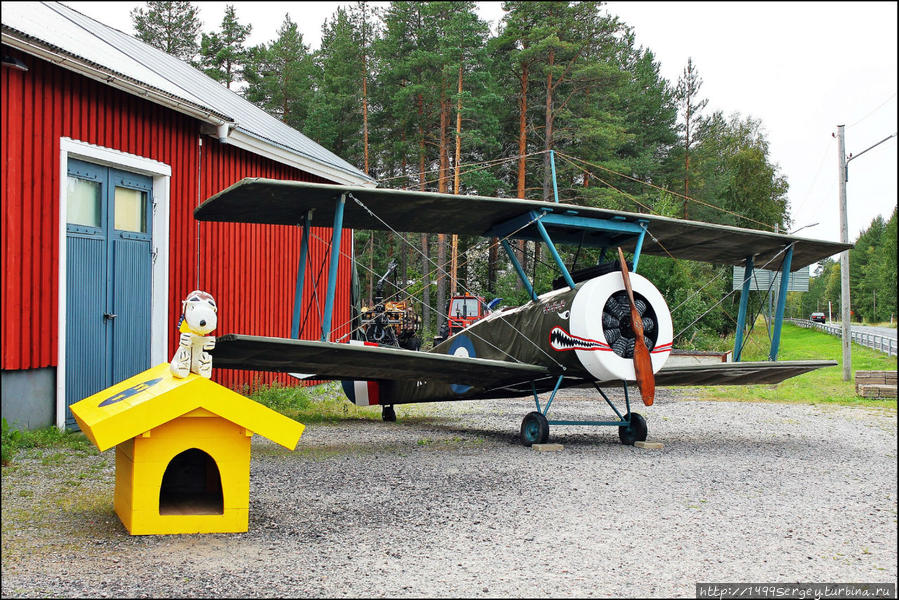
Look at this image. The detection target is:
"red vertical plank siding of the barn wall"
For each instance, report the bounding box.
[0,46,352,387]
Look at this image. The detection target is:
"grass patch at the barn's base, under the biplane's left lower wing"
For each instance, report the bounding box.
[244,381,381,423]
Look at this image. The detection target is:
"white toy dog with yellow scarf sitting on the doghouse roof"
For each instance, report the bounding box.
[169,290,218,378]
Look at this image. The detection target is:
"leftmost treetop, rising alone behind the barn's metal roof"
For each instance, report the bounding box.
[131,1,200,64]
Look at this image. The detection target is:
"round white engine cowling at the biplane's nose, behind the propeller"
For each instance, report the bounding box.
[569,271,674,381]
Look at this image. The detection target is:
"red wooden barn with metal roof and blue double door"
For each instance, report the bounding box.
[2,2,373,428]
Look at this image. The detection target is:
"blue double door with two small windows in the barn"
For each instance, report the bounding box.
[65,159,153,428]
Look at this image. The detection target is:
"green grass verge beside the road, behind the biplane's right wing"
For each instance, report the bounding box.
[699,323,896,409]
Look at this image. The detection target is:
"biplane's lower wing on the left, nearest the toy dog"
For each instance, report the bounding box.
[211,334,549,387]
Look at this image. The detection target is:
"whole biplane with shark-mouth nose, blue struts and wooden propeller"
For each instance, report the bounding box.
[194,178,851,446]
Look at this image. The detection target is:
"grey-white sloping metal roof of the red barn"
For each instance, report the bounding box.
[2,2,374,185]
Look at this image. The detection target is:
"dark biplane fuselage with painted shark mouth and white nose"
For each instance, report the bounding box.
[344,272,672,405]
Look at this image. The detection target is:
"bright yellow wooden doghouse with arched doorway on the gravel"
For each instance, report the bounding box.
[71,363,303,535]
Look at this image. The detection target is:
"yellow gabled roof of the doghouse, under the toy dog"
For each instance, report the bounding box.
[71,363,304,452]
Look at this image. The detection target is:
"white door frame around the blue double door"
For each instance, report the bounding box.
[56,137,172,429]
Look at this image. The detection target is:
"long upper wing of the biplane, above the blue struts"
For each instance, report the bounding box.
[194,178,852,271]
